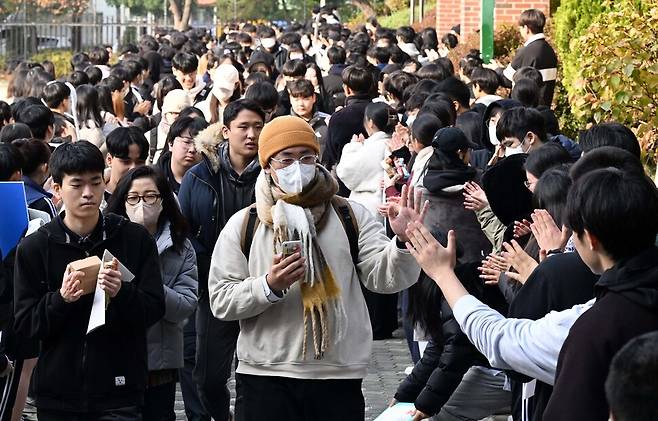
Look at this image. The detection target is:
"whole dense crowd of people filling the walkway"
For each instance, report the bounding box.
[0,7,658,421]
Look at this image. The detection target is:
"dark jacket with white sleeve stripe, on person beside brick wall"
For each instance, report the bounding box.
[503,34,557,107]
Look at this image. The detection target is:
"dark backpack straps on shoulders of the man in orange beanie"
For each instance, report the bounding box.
[240,196,359,268]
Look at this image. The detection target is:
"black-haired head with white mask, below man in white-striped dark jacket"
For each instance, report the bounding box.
[496,107,547,156]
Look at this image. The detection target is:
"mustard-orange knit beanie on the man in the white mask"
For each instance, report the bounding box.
[258,116,320,168]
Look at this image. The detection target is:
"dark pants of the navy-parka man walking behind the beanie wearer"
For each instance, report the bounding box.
[194,292,240,421]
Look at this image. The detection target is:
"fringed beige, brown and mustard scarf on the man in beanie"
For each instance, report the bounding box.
[256,165,347,359]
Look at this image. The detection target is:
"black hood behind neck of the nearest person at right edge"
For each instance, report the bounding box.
[595,246,658,310]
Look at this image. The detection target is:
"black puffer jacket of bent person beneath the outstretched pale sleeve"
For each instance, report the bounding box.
[395,262,506,415]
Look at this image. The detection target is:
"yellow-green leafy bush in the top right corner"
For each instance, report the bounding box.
[556,0,658,166]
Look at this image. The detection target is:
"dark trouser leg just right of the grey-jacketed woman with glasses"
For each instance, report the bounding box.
[178,312,210,421]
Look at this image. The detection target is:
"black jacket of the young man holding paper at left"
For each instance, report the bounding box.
[14,214,164,413]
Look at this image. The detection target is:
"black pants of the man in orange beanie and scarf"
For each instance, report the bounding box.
[234,374,365,421]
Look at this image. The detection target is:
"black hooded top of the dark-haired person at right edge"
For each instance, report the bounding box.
[543,247,658,421]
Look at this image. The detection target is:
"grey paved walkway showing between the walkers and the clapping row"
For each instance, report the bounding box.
[176,330,411,421]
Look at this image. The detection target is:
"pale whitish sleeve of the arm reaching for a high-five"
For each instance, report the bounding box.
[453,295,594,385]
